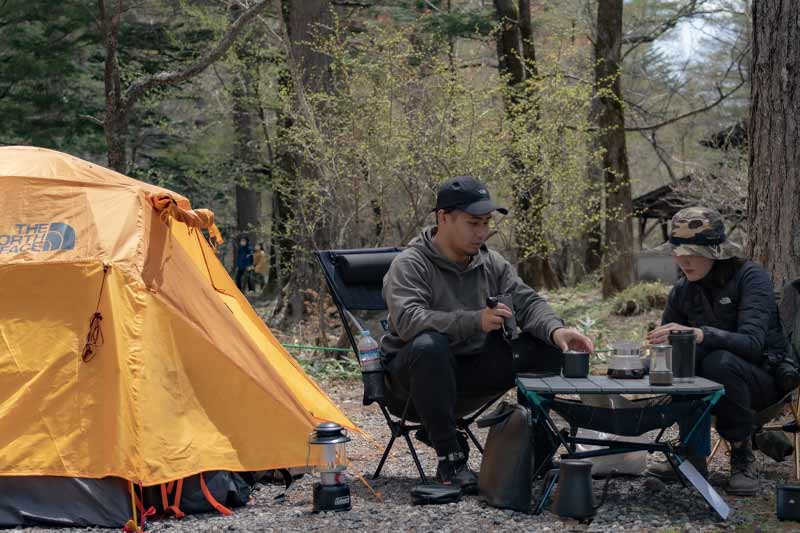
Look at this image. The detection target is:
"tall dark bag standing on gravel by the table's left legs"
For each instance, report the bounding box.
[477,402,534,512]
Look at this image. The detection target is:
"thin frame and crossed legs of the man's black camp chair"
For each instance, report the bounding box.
[314,248,496,483]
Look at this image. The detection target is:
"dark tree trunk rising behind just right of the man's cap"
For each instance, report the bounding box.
[494,0,560,289]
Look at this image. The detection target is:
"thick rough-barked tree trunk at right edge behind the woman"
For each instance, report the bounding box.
[747,0,800,287]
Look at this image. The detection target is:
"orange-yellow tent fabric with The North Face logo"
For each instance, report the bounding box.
[0,147,356,485]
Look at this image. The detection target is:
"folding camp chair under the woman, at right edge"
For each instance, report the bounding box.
[708,279,800,480]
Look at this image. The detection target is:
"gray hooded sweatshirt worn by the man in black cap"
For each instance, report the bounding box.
[381,227,564,355]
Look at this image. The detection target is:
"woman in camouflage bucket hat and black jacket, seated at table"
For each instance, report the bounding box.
[647,207,789,495]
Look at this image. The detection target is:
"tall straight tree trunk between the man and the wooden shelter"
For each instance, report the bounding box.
[595,0,636,297]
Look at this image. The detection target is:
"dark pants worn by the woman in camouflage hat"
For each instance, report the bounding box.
[681,350,780,455]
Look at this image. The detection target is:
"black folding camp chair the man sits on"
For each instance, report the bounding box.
[315,248,502,482]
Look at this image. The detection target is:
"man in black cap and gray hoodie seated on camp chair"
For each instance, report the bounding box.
[382,176,593,493]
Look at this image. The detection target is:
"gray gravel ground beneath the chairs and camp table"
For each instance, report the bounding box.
[15,382,800,533]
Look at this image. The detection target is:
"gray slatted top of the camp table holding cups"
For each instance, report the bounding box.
[518,375,722,396]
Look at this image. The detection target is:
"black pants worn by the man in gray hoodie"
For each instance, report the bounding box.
[387,331,562,457]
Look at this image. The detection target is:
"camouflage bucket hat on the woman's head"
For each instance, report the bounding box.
[661,207,742,259]
